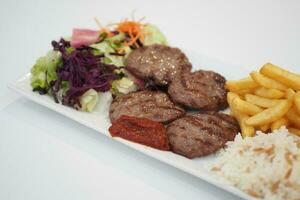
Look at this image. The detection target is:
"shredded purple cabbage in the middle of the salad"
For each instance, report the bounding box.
[50,39,117,108]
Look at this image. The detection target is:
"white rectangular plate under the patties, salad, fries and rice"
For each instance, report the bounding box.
[9,52,253,199]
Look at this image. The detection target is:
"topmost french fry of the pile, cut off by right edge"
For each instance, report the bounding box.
[260,63,300,90]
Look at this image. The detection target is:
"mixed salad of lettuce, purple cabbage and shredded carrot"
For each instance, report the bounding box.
[31,16,167,112]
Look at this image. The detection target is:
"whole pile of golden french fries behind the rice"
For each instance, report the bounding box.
[226,63,300,137]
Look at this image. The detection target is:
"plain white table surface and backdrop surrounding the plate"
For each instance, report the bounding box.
[0,0,300,200]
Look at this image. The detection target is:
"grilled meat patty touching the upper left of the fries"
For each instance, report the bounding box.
[168,70,227,110]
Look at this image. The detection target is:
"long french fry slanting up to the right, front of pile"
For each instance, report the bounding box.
[245,100,292,126]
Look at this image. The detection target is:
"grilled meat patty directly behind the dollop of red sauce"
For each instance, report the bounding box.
[109,90,185,123]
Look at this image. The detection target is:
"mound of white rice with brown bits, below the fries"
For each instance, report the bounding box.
[211,127,300,200]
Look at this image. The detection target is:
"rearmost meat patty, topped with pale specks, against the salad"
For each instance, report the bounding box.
[125,44,192,85]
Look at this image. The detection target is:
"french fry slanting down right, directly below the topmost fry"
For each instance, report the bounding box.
[250,71,288,91]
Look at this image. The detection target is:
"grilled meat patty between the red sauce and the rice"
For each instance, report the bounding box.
[167,112,239,158]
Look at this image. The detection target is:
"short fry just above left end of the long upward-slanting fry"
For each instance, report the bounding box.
[232,98,263,115]
